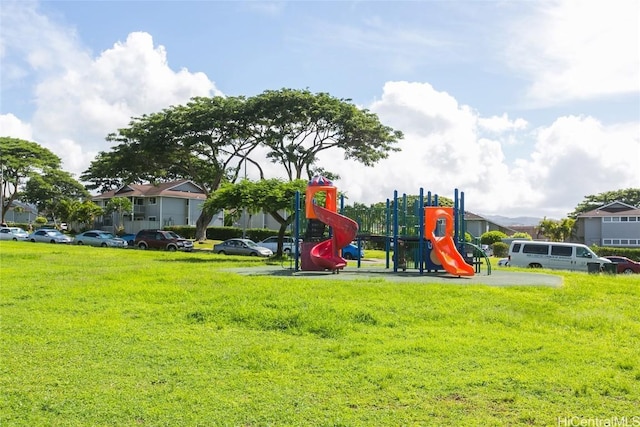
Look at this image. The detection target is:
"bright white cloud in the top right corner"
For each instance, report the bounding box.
[507,0,640,105]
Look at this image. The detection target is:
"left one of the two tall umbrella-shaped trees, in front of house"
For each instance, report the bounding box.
[81,97,263,240]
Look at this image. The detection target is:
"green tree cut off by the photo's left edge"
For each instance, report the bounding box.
[0,137,60,222]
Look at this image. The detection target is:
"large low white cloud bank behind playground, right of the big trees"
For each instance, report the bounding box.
[326,82,640,218]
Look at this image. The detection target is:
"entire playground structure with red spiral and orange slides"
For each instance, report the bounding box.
[295,177,491,277]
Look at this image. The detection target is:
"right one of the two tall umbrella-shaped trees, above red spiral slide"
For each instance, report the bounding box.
[247,89,403,180]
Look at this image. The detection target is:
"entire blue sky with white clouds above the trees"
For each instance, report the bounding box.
[0,0,640,219]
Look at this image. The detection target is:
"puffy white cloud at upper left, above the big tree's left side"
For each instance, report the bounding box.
[33,33,219,150]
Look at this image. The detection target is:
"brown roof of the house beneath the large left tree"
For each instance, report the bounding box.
[93,180,207,200]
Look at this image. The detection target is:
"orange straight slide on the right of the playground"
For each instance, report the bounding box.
[424,206,474,276]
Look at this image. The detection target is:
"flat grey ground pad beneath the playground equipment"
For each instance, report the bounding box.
[225,265,562,287]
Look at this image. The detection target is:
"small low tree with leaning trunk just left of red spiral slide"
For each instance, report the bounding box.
[203,179,307,256]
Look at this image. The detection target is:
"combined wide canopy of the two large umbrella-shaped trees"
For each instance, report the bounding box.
[81,89,402,239]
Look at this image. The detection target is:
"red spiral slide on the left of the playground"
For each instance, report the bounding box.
[309,204,358,271]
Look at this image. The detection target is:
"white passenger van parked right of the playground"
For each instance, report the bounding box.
[509,240,611,272]
